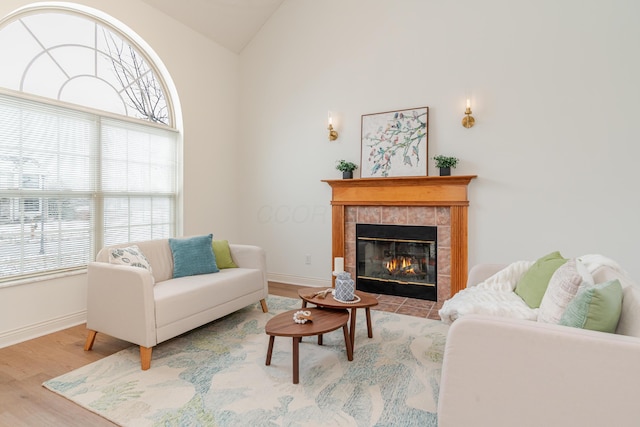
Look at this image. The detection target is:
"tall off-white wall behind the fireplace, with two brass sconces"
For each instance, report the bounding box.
[239,0,640,284]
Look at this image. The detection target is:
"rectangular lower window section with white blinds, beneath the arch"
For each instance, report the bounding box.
[0,95,176,280]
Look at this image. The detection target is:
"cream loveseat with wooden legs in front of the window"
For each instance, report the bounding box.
[85,239,268,370]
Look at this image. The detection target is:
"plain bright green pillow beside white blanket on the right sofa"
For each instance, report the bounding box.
[515,251,568,308]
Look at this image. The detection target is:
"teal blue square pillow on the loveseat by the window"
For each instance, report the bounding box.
[169,234,220,279]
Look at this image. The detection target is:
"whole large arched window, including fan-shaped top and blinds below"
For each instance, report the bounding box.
[0,4,178,284]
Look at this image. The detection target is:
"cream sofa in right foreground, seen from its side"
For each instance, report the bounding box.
[438,264,640,427]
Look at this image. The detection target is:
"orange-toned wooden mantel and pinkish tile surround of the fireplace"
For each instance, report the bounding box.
[324,175,476,303]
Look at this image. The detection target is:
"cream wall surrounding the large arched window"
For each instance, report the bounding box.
[0,0,239,347]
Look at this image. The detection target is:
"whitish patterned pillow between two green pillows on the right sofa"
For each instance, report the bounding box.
[538,259,594,324]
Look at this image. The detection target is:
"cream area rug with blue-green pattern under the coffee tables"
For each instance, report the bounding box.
[43,296,448,427]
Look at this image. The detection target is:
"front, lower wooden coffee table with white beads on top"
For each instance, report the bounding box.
[264,308,353,384]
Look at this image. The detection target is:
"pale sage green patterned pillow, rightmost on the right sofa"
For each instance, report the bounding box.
[560,279,622,333]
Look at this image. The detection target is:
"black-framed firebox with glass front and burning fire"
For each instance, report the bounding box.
[356,224,438,301]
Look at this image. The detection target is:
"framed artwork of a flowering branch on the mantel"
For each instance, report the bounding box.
[360,107,429,178]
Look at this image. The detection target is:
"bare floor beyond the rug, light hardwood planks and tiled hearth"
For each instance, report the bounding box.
[0,283,439,427]
